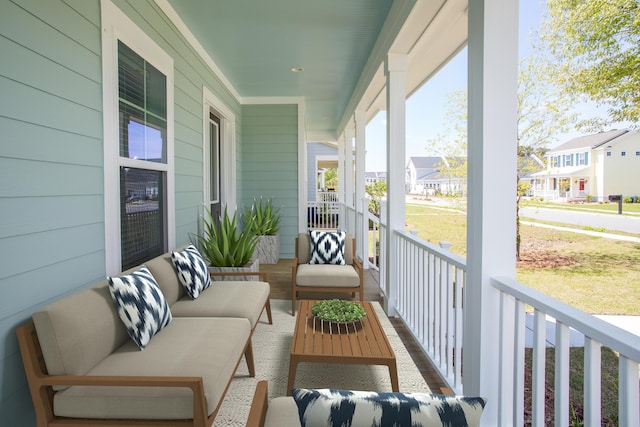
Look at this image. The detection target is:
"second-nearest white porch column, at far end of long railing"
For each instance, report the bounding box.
[385,53,408,316]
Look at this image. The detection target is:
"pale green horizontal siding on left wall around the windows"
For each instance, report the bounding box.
[0,0,242,425]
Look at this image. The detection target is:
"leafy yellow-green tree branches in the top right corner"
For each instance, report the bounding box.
[541,0,640,126]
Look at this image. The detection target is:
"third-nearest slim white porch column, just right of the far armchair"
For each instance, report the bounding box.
[354,110,369,268]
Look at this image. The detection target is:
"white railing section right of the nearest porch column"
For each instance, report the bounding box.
[492,277,640,427]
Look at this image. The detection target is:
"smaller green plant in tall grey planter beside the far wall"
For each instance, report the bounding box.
[243,197,280,264]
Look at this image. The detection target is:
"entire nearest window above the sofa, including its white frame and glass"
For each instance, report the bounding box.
[101,0,175,274]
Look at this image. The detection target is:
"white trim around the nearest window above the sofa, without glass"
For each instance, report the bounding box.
[100,0,176,275]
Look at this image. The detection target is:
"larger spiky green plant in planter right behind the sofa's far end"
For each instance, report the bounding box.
[196,207,260,280]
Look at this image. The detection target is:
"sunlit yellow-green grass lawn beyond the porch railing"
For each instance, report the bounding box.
[407,205,640,315]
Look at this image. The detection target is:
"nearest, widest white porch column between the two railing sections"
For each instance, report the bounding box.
[463,0,518,426]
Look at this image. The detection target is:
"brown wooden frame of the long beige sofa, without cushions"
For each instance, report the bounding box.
[16,272,272,427]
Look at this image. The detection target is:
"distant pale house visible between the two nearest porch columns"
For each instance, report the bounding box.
[406,156,467,195]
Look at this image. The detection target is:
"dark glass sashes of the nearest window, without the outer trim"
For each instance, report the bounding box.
[118,41,167,270]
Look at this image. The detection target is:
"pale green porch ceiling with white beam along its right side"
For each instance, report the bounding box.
[164,0,467,141]
